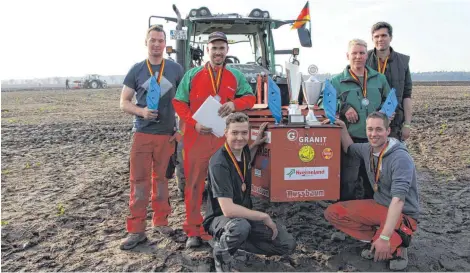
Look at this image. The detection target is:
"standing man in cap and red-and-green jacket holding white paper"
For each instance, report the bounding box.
[173,32,255,248]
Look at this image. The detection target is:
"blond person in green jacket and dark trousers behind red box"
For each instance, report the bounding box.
[331,39,390,201]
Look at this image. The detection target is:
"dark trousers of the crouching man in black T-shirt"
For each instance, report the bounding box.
[209,216,297,256]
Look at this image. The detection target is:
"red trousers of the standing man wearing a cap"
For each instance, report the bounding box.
[183,134,225,236]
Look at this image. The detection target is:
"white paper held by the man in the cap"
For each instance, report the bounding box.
[193,96,226,137]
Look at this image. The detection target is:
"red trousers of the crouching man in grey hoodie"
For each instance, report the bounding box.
[325,199,417,254]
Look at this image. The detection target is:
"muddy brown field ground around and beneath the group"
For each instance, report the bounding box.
[1,86,470,271]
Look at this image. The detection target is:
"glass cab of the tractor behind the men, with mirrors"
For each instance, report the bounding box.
[149,5,312,106]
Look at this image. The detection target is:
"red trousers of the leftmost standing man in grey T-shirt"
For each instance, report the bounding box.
[127,133,175,233]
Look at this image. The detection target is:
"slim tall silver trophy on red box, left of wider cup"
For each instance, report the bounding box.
[286,62,305,124]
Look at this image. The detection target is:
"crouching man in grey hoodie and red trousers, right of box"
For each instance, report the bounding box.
[325,112,419,270]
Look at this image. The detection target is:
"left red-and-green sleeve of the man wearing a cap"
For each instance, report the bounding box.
[172,70,197,127]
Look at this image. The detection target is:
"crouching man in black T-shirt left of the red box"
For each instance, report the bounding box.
[203,113,296,272]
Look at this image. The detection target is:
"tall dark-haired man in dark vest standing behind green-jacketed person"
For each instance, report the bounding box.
[367,22,413,140]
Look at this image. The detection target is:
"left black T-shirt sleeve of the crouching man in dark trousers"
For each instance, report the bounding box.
[209,164,233,198]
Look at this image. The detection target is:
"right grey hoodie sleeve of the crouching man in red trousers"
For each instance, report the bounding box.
[391,154,414,201]
